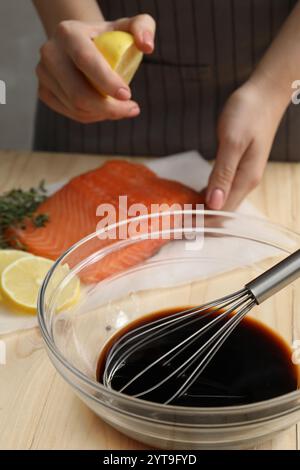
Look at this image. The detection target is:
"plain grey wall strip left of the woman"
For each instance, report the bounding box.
[0,0,44,150]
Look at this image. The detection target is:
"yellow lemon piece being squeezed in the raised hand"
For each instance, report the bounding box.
[94,31,143,84]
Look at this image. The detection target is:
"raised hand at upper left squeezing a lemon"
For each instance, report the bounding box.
[37,15,155,124]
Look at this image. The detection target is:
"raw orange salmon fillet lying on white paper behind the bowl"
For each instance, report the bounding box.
[10,160,203,282]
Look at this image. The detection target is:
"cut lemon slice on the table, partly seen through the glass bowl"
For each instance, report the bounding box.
[1,256,80,313]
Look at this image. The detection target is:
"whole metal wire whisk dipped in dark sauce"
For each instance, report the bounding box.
[103,250,300,404]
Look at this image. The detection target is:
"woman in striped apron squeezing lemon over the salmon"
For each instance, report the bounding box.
[34,0,300,209]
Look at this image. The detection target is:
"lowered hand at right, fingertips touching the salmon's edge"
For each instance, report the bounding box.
[206,80,286,210]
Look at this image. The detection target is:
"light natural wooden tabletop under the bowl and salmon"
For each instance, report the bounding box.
[0,152,300,450]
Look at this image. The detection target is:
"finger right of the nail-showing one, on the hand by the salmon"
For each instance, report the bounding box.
[224,143,268,211]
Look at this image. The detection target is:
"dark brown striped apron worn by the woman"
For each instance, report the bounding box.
[34,0,300,161]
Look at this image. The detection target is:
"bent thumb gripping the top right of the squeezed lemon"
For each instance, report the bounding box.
[114,14,156,54]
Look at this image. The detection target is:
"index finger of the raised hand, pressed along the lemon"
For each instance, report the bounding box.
[58,22,131,100]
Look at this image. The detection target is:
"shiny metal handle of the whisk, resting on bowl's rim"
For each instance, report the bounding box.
[246,246,300,304]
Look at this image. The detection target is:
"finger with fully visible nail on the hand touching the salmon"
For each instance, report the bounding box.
[206,137,247,210]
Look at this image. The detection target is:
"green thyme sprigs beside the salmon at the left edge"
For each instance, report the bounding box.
[0,181,49,249]
